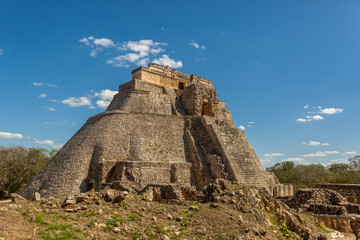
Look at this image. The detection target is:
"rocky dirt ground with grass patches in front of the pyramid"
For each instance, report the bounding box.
[0,184,342,240]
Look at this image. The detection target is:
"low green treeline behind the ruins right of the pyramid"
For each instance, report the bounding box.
[266,155,360,192]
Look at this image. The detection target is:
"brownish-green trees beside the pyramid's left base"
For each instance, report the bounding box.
[0,146,58,198]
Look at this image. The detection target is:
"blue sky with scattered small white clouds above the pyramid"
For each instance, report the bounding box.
[0,0,360,167]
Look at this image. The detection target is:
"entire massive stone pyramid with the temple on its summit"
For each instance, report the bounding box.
[21,63,292,200]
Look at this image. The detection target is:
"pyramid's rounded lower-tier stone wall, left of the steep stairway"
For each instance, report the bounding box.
[21,111,186,199]
